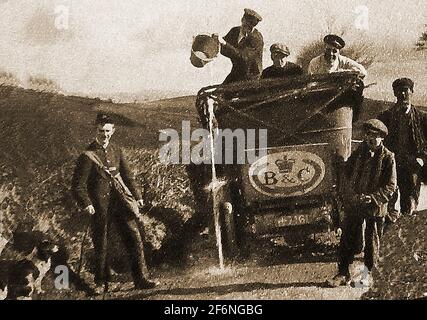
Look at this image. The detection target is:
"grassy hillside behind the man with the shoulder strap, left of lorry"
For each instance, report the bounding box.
[0,86,201,270]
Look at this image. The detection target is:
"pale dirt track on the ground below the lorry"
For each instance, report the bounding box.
[95,234,365,300]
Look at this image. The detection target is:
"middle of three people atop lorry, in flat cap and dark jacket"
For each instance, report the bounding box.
[261,43,304,79]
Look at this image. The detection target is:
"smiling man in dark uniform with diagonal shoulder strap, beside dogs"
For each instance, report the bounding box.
[72,114,156,292]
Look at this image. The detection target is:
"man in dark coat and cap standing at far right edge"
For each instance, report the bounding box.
[378,78,427,220]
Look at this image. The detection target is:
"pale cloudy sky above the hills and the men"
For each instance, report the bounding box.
[0,0,427,97]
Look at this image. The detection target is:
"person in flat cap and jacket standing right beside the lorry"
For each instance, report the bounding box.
[327,119,397,287]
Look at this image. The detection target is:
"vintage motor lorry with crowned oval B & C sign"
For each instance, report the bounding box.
[191,72,364,257]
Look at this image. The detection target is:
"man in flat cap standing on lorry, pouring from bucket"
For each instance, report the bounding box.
[218,9,264,84]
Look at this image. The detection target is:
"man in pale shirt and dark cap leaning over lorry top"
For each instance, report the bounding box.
[308,34,368,78]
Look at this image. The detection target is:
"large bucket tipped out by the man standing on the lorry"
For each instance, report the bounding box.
[190,34,219,68]
